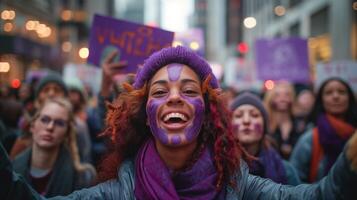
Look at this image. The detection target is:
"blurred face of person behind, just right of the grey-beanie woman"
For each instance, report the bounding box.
[271,85,293,112]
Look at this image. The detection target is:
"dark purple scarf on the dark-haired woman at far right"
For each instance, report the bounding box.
[317,114,352,174]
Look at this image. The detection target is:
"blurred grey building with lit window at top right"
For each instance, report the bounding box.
[241,0,357,66]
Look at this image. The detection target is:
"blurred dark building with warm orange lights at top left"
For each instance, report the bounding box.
[0,0,114,87]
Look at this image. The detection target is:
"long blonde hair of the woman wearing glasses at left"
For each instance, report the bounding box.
[30,97,96,175]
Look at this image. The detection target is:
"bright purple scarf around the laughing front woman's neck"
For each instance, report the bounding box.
[134,139,225,199]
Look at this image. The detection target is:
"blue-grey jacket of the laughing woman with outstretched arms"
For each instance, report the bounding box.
[0,145,357,200]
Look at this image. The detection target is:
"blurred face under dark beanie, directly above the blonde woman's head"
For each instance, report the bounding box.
[37,82,65,105]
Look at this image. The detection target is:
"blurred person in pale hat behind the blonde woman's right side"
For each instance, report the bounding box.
[65,78,92,162]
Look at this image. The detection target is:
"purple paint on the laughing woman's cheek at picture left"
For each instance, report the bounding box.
[146,98,169,144]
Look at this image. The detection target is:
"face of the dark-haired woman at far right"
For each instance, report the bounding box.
[322,80,349,117]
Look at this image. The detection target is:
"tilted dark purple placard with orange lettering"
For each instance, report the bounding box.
[88,15,174,73]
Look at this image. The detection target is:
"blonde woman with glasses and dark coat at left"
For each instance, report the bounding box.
[13,98,96,197]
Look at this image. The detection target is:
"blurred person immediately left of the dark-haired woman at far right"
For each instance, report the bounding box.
[293,88,315,133]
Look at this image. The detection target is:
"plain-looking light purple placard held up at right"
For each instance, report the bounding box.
[255,38,310,83]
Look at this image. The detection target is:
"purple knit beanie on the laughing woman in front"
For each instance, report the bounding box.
[133,46,219,89]
